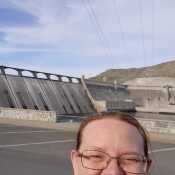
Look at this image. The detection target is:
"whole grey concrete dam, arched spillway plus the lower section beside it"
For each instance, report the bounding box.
[0,66,134,120]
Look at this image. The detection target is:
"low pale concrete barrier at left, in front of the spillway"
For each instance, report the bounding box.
[0,107,57,122]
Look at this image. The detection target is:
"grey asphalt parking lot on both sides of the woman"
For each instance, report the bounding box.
[0,124,175,175]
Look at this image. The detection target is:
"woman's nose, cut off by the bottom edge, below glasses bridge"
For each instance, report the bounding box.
[102,159,126,175]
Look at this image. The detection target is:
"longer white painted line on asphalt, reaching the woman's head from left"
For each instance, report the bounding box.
[0,139,75,148]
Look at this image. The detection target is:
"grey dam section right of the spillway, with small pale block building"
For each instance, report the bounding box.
[86,80,135,111]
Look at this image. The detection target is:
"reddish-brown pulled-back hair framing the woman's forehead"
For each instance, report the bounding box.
[76,112,150,158]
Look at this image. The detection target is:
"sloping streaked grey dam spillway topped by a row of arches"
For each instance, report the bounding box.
[0,67,94,115]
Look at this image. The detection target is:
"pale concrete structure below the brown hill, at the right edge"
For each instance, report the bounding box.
[124,77,175,114]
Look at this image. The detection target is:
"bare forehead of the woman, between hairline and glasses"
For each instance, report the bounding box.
[81,119,143,154]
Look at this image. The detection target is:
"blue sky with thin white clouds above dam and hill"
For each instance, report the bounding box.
[0,0,175,77]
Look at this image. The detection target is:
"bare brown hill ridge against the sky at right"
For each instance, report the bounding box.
[90,61,175,83]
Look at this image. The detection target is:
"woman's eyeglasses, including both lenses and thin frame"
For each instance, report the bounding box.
[78,150,150,174]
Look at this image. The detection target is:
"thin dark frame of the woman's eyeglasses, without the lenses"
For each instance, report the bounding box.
[77,149,151,174]
